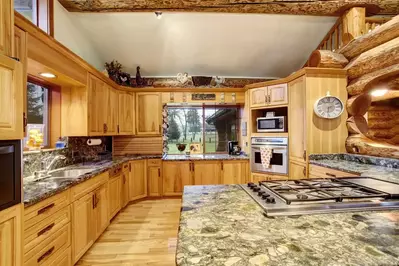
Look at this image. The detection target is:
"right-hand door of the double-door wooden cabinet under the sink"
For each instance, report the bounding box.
[94,183,110,239]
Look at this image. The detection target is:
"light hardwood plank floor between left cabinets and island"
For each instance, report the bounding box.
[76,199,181,266]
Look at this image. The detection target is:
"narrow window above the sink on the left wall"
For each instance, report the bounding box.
[24,82,49,150]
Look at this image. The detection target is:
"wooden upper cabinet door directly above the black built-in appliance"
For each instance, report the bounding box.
[0,55,24,139]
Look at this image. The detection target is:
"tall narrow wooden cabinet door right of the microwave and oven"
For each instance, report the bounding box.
[288,77,306,163]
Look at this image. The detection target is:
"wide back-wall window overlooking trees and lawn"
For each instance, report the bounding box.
[167,106,239,154]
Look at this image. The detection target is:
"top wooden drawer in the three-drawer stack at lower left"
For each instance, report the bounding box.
[24,190,70,230]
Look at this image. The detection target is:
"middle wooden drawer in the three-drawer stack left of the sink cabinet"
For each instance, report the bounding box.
[24,206,71,253]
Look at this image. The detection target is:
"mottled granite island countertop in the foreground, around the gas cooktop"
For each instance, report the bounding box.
[176,185,399,266]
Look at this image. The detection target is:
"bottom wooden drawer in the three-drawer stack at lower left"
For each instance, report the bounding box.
[24,224,71,266]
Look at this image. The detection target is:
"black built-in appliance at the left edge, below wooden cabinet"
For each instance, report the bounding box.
[0,140,22,210]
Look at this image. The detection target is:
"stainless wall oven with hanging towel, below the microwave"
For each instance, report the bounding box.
[251,137,288,175]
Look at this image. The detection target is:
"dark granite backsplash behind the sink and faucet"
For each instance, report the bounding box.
[22,137,112,177]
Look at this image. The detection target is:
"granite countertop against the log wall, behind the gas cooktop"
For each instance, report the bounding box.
[309,153,399,183]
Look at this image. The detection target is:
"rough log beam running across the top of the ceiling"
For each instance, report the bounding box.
[59,0,399,16]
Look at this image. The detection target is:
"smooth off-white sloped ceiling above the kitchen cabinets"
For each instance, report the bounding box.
[70,13,336,78]
